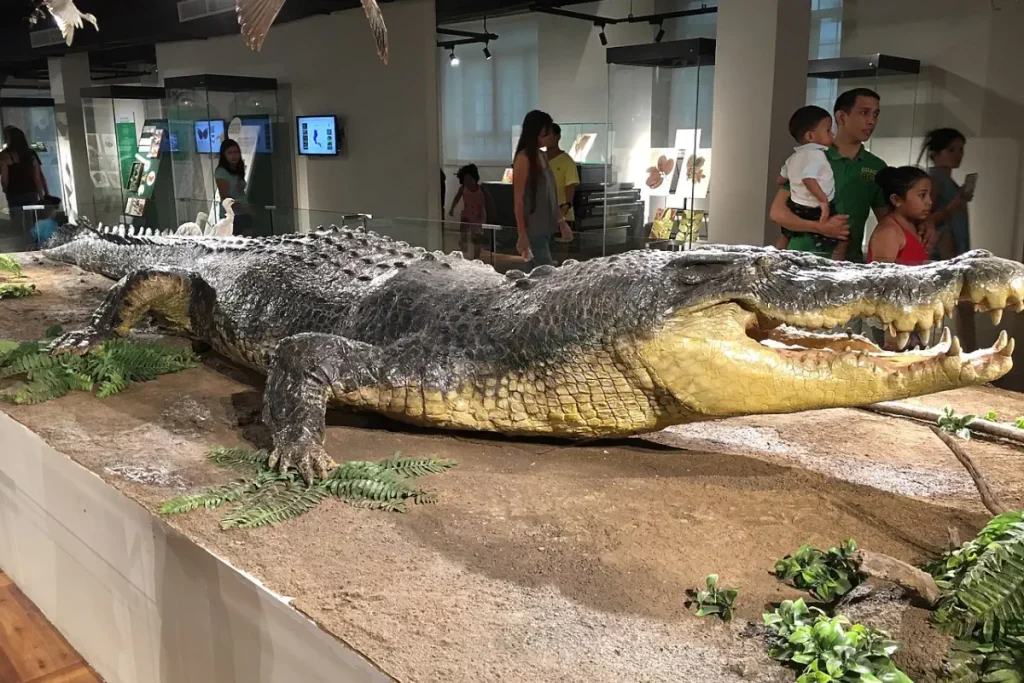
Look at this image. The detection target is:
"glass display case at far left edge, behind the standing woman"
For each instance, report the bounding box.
[0,97,63,252]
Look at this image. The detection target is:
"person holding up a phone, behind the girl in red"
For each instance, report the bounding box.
[918,128,974,259]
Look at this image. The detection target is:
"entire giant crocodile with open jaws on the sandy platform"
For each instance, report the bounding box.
[39,225,1024,480]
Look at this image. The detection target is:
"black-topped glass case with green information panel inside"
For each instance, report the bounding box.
[81,85,177,229]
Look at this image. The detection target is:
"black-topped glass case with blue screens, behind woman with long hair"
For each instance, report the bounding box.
[164,74,286,236]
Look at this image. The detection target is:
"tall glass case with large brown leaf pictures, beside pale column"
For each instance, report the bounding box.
[606,38,715,254]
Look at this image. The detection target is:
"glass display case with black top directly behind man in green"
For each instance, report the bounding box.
[807,54,924,166]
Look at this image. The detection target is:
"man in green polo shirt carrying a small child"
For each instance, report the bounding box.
[770,88,889,263]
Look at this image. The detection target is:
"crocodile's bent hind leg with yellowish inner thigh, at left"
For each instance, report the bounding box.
[49,268,214,354]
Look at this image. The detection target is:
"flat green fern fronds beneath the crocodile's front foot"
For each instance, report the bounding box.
[160,446,456,529]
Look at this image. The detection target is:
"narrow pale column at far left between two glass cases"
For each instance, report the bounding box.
[49,52,94,219]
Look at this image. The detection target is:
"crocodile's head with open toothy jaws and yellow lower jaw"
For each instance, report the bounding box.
[634,247,1024,419]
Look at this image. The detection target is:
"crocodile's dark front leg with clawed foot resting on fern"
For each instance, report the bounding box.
[263,333,383,483]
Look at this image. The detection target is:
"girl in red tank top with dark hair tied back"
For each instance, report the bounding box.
[867,166,932,265]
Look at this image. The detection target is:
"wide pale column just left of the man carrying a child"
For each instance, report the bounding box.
[709,0,811,246]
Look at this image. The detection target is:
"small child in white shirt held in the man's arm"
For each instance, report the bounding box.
[775,105,849,261]
